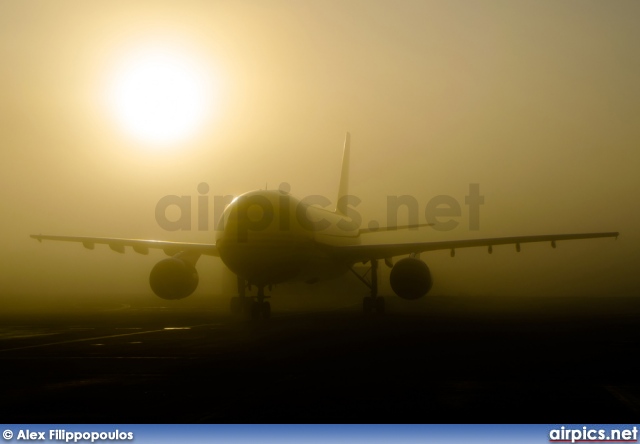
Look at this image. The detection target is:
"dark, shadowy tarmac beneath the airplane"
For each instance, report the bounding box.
[0,297,640,423]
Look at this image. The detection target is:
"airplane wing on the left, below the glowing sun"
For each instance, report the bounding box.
[31,234,218,256]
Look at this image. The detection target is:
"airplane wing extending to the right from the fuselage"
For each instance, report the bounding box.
[329,232,620,263]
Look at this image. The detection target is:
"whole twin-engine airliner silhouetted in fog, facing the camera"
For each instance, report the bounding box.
[30,133,619,319]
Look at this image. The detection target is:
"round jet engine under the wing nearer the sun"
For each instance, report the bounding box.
[149,257,199,299]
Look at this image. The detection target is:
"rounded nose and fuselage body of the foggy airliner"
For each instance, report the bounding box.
[216,190,360,286]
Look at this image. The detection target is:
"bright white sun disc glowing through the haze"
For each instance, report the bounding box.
[108,48,213,146]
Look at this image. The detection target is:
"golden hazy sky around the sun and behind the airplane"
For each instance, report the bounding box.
[0,0,640,304]
